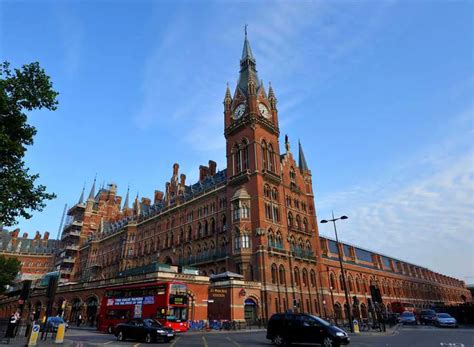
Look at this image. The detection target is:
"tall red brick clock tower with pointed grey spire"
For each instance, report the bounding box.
[224,33,283,281]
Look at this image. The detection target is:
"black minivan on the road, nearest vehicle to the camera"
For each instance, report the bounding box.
[267,313,350,347]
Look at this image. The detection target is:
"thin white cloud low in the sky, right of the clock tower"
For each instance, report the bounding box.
[316,108,474,280]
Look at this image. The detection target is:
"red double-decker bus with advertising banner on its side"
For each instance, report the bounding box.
[97,282,188,333]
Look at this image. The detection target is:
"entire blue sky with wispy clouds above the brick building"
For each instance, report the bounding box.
[0,0,474,283]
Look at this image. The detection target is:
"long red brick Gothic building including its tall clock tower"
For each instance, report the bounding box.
[0,33,472,319]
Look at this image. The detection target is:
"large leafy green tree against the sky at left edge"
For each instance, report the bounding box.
[0,62,58,226]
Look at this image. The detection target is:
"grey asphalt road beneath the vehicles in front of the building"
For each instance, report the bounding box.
[21,326,474,347]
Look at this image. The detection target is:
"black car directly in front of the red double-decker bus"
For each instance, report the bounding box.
[114,318,174,343]
